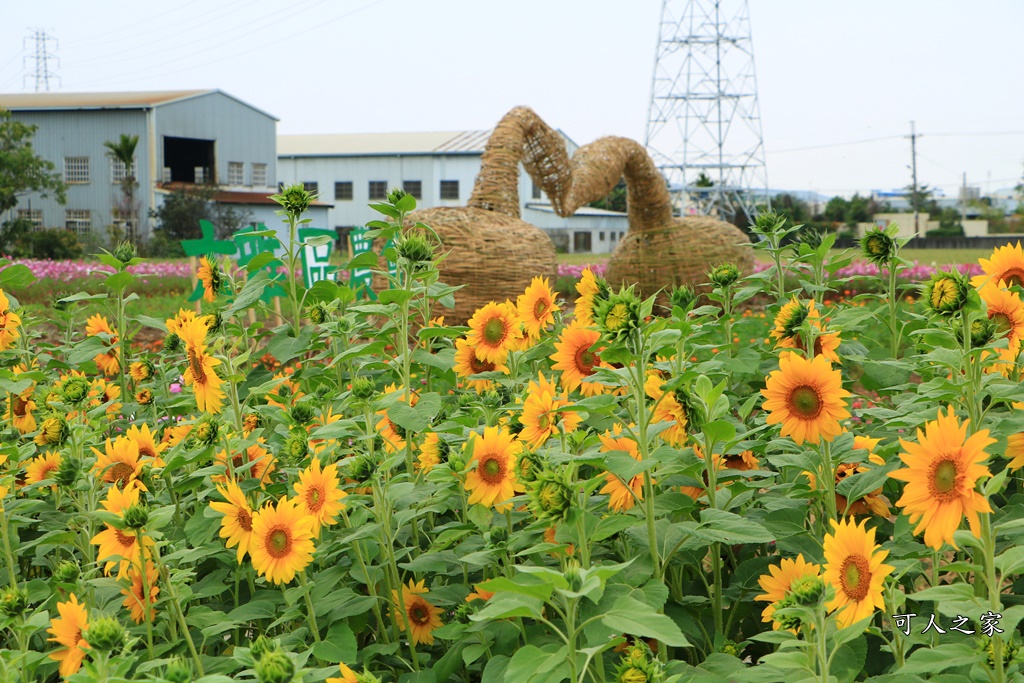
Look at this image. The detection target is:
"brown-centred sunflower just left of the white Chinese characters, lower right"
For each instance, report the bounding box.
[823,519,893,629]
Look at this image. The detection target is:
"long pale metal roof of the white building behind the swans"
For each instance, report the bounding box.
[278,130,490,157]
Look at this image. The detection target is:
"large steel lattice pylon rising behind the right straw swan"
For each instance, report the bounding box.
[644,0,770,220]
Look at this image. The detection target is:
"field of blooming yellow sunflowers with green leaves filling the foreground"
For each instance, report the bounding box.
[0,185,1024,683]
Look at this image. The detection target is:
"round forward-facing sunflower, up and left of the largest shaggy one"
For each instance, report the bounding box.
[761,352,850,445]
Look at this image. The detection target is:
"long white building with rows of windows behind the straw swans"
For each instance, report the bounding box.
[278,130,627,253]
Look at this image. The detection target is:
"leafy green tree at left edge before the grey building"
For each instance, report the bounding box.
[0,110,68,213]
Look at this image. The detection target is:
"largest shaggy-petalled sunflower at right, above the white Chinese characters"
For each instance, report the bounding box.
[889,405,995,550]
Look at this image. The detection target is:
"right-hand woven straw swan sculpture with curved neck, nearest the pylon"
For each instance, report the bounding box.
[546,137,754,296]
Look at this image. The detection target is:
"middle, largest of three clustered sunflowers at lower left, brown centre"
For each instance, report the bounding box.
[249,498,315,584]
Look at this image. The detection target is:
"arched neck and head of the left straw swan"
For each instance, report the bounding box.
[466,106,572,218]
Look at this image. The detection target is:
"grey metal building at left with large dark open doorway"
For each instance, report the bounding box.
[0,90,327,241]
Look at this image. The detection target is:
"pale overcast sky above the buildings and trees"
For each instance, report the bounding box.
[0,0,1024,195]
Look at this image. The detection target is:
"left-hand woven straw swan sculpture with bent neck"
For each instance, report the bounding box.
[374,106,571,325]
